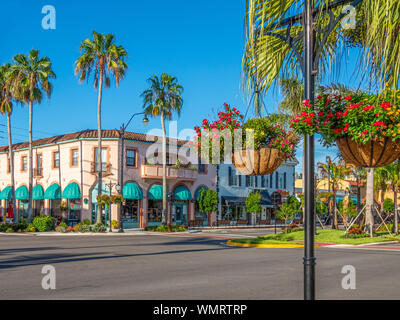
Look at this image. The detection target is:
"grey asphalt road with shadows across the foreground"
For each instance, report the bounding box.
[0,230,400,300]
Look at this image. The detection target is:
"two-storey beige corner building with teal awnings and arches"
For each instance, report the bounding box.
[0,130,216,228]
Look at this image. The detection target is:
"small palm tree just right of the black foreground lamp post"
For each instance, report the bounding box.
[317,157,350,229]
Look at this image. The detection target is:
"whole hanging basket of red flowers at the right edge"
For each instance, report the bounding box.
[290,87,400,168]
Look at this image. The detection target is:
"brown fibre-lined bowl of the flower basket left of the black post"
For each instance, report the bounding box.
[232,147,286,176]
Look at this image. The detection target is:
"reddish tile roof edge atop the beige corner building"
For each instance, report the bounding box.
[0,129,188,152]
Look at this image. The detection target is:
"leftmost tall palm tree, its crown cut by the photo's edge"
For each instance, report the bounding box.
[0,63,18,222]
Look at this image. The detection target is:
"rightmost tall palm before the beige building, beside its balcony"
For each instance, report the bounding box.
[141,73,183,224]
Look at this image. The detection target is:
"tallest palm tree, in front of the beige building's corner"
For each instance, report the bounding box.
[75,31,128,222]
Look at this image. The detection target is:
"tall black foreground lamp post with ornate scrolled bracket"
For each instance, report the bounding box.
[264,0,363,300]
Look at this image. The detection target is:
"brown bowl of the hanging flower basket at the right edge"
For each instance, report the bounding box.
[336,136,400,168]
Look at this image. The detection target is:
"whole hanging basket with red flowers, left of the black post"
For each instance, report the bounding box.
[194,103,299,175]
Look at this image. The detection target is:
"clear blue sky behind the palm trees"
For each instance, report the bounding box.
[0,0,362,171]
